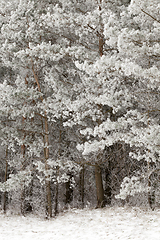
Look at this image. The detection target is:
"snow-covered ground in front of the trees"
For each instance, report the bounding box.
[0,208,160,240]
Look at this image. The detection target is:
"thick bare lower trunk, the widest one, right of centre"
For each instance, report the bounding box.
[95,164,105,208]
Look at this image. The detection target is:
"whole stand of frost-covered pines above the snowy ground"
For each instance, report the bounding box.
[0,0,160,217]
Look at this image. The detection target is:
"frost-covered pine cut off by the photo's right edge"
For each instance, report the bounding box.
[115,0,160,207]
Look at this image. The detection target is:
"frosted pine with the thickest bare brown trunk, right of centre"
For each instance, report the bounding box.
[61,1,133,207]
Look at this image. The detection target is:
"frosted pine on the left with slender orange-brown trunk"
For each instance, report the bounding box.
[0,0,79,217]
